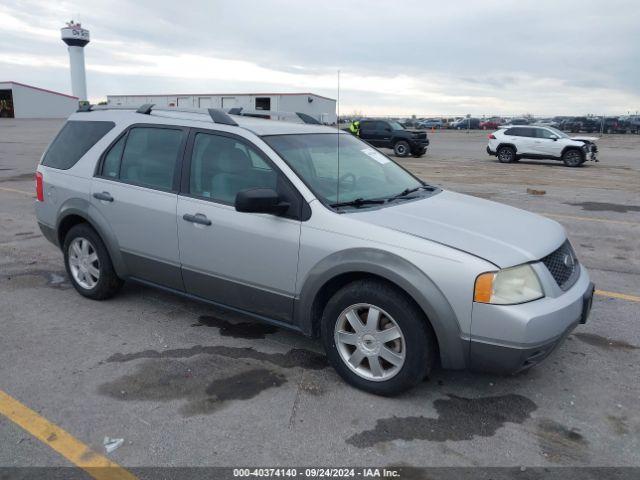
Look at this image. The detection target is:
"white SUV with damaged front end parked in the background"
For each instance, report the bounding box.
[487,125,598,167]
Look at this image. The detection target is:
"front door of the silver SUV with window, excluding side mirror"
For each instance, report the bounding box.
[177,131,300,322]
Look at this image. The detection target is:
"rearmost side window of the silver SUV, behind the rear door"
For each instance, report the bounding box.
[42,121,116,170]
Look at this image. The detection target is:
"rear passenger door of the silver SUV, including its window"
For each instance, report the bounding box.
[91,125,187,290]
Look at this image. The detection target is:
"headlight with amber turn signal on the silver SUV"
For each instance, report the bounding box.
[473,264,544,305]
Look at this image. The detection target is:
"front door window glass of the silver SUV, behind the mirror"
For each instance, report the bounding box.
[189,133,278,204]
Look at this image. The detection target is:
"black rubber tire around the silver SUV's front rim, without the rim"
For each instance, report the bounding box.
[321,280,436,396]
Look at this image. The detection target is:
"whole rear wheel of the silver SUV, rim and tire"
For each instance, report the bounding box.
[63,223,123,300]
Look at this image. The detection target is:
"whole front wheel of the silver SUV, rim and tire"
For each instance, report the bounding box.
[321,281,435,396]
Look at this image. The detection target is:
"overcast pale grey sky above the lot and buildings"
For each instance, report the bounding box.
[0,0,640,116]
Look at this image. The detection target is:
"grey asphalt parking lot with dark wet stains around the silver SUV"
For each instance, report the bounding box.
[0,119,640,467]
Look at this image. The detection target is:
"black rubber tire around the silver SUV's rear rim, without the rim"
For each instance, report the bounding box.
[62,223,124,300]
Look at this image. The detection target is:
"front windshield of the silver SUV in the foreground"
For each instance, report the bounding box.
[263,133,423,204]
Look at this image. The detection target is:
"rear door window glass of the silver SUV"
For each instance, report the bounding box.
[119,127,184,190]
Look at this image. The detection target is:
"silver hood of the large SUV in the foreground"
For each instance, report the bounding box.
[349,191,566,268]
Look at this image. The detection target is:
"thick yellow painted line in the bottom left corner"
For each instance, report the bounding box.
[0,390,137,480]
